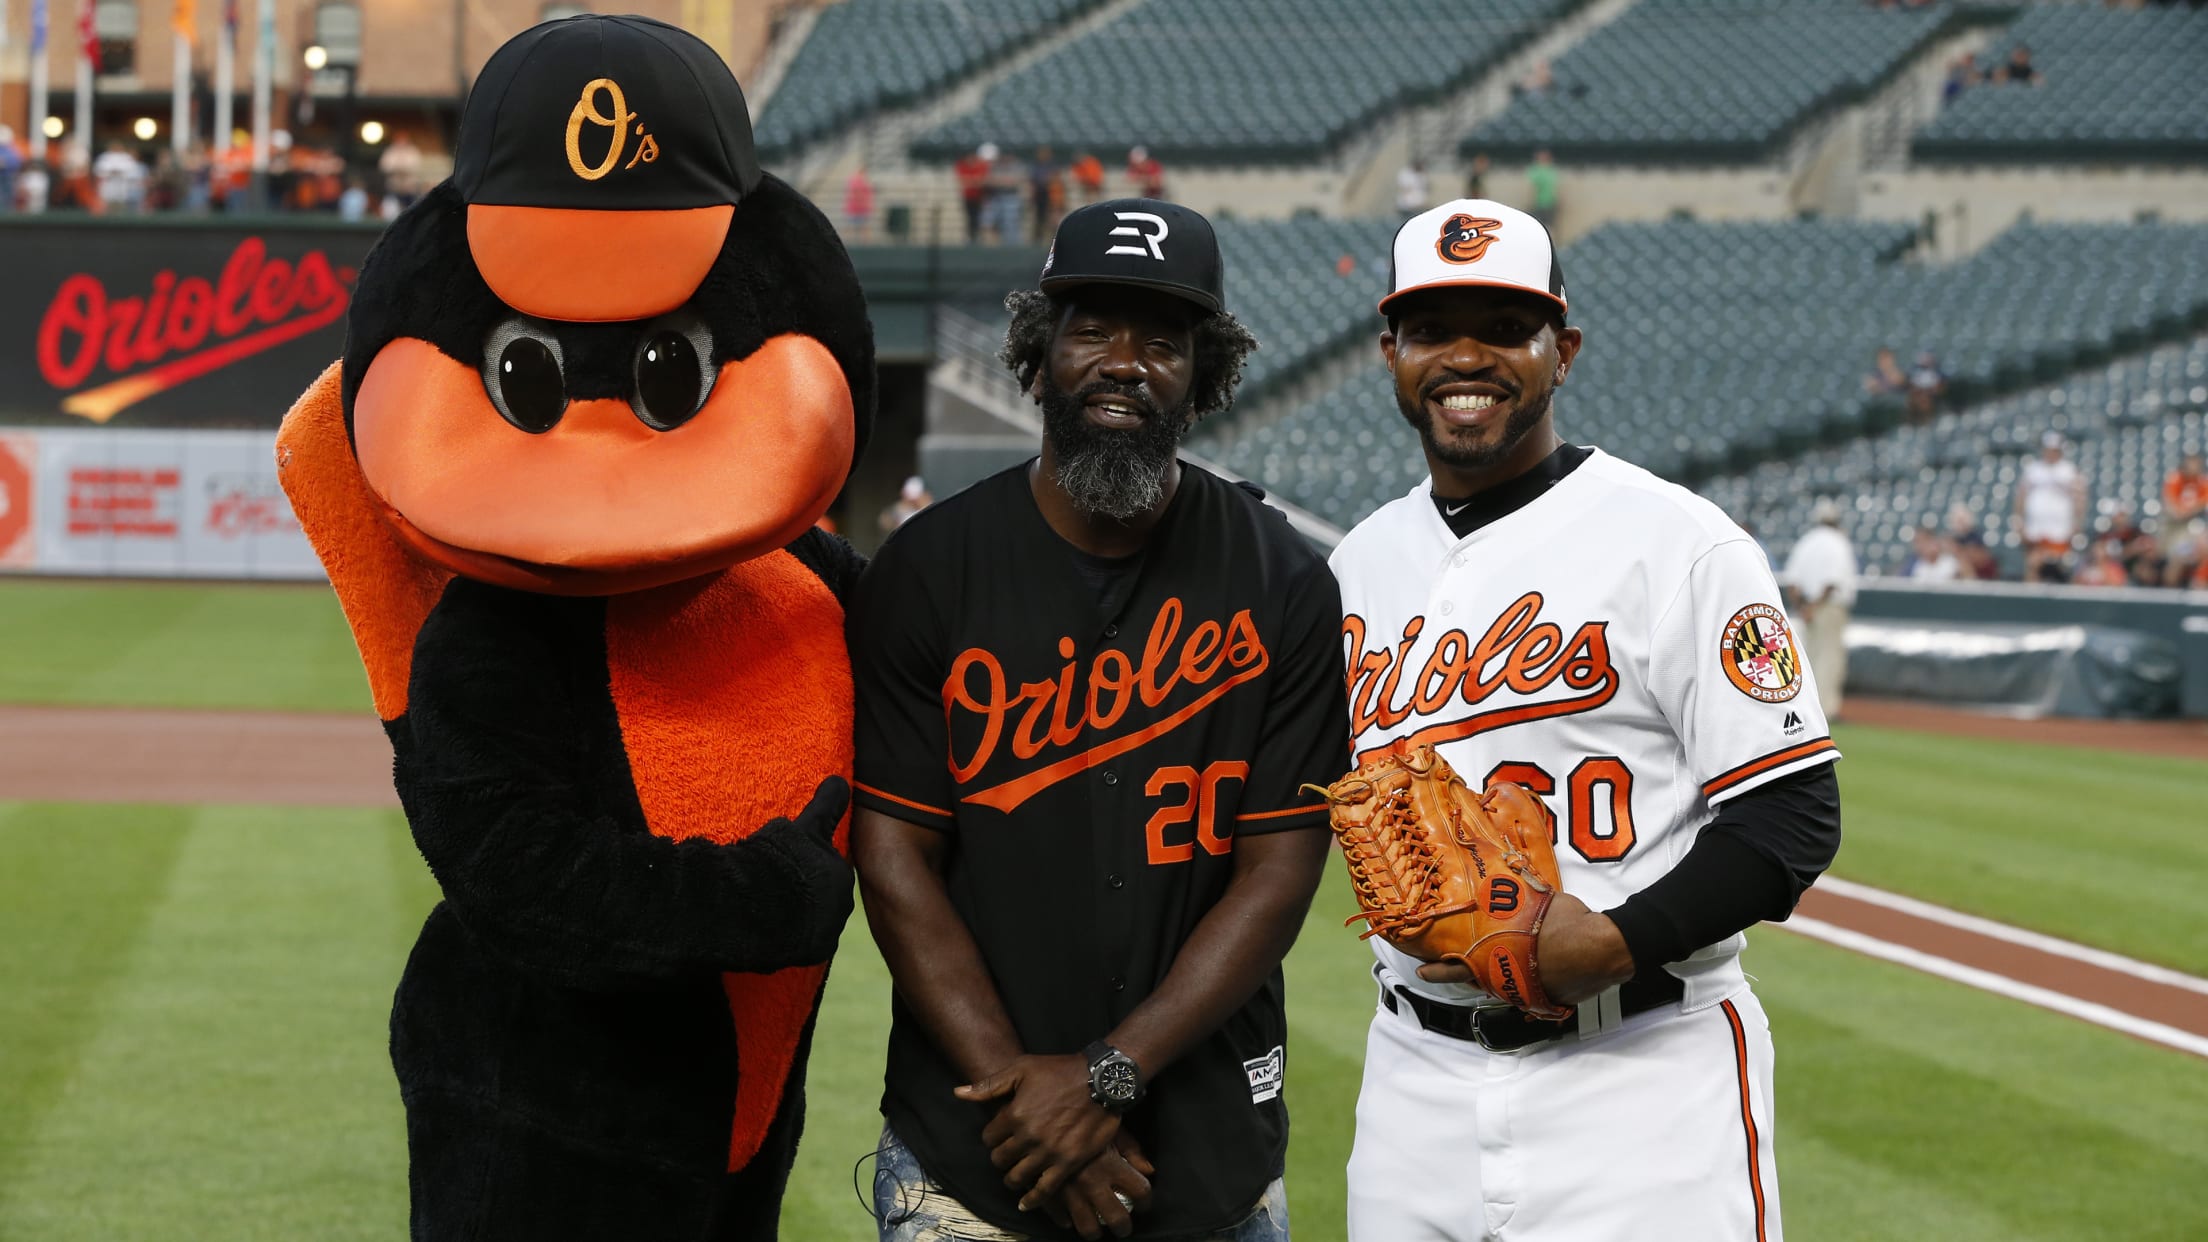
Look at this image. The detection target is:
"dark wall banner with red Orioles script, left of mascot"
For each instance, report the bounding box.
[0,217,378,429]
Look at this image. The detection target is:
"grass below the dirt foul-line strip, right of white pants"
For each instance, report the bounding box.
[1747,928,2208,1242]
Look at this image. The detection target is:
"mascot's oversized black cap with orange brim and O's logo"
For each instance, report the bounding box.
[453,13,760,320]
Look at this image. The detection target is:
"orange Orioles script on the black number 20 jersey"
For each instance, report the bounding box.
[943,599,1272,813]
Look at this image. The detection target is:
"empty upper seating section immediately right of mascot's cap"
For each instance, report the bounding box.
[757,0,1102,159]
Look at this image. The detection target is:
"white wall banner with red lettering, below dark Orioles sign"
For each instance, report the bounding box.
[0,429,322,579]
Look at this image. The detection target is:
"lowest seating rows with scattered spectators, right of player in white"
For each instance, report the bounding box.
[1700,338,2208,575]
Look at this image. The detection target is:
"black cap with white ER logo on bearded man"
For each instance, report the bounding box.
[1038,199,1225,312]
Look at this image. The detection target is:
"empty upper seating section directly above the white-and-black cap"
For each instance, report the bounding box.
[1464,0,1958,164]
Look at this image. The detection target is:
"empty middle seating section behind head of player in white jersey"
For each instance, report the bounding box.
[1195,221,2208,524]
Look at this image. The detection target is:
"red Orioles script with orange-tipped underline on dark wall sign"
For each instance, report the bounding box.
[38,236,353,422]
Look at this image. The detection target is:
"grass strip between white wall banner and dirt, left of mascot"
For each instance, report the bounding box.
[0,579,369,712]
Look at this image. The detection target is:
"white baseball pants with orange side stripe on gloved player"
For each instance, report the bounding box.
[1349,988,1780,1242]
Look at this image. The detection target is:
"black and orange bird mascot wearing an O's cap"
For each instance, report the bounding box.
[278,15,874,1240]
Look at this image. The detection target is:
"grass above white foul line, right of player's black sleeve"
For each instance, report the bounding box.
[1833,727,2208,975]
